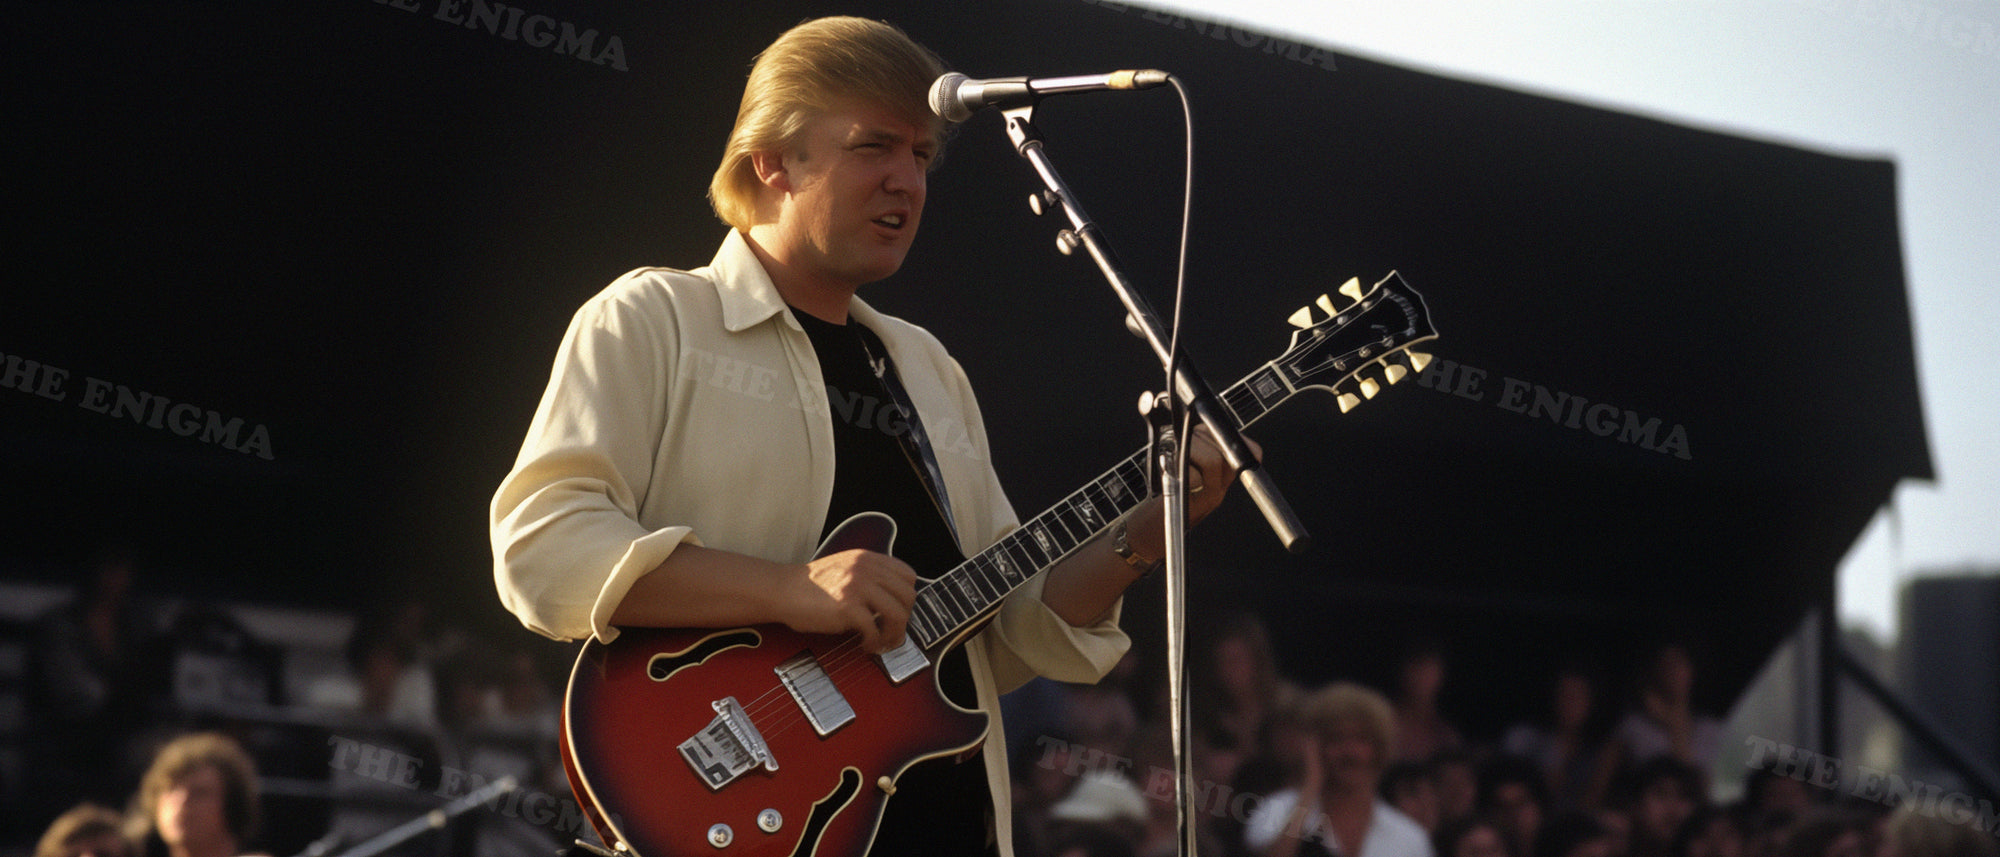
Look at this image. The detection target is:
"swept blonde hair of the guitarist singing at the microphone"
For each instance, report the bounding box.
[708,16,946,230]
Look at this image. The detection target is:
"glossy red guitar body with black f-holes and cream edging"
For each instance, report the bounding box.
[562,517,988,857]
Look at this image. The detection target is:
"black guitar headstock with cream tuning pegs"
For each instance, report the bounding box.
[1272,270,1438,412]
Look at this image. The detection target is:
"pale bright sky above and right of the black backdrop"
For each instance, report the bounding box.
[1168,0,2000,643]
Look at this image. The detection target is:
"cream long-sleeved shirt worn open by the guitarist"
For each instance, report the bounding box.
[490,230,1130,853]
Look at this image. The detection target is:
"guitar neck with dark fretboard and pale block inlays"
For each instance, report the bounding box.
[910,362,1298,649]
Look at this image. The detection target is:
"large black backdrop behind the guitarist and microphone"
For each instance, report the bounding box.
[0,0,1930,740]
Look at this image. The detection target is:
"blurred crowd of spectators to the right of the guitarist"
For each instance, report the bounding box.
[992,615,2000,857]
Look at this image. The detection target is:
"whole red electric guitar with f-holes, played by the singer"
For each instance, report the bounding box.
[562,272,1436,857]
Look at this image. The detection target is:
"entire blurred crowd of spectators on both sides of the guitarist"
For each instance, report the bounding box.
[7,557,2000,857]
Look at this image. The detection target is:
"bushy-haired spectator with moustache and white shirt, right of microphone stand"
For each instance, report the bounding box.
[1244,683,1432,857]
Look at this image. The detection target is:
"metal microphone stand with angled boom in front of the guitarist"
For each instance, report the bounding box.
[1002,104,1310,857]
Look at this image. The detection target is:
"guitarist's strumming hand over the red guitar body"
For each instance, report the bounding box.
[782,549,916,653]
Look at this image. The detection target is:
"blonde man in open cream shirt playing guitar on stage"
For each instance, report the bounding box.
[492,18,1234,855]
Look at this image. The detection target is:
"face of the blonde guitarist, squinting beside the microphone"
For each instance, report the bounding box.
[778,98,938,288]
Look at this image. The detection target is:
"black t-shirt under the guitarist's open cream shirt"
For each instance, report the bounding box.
[792,308,994,857]
